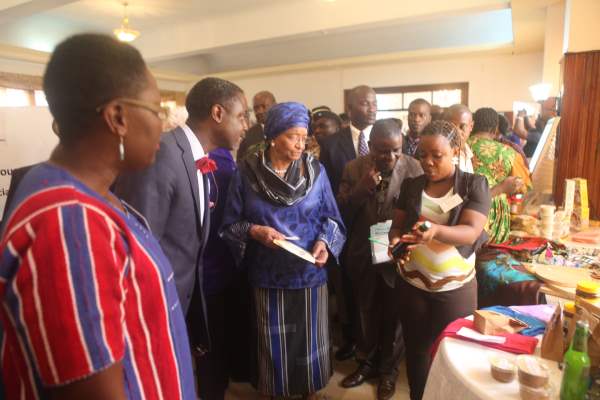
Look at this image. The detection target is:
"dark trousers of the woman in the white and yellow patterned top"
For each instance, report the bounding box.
[398,279,477,400]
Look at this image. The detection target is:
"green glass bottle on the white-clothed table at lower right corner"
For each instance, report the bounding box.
[560,321,590,400]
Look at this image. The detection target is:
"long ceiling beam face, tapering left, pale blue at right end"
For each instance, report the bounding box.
[153,9,513,75]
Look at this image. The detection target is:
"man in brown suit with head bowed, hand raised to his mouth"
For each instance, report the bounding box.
[337,118,423,400]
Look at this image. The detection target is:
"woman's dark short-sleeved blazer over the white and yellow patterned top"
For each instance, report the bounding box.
[396,168,492,258]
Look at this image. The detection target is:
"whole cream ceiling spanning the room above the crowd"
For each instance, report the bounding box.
[0,0,557,79]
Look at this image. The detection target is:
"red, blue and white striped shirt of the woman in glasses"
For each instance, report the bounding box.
[0,164,196,400]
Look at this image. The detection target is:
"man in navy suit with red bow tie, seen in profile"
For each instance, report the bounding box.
[115,78,248,400]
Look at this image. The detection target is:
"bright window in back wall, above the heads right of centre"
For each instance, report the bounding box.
[346,82,469,130]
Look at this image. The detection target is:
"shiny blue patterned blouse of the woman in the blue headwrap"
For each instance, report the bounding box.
[220,164,345,289]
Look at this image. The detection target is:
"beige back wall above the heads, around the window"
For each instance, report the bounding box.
[229,53,543,112]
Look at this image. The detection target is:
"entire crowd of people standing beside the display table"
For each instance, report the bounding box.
[0,34,552,400]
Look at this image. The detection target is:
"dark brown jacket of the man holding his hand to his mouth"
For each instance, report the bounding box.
[337,154,423,293]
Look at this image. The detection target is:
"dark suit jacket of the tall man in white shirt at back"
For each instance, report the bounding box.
[320,127,356,195]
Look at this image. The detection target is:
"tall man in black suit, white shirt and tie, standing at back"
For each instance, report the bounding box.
[320,85,377,361]
